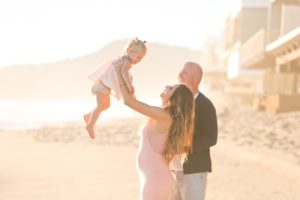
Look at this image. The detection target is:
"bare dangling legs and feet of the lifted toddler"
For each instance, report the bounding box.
[84,93,110,139]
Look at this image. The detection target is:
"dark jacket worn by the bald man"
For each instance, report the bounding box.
[183,92,218,174]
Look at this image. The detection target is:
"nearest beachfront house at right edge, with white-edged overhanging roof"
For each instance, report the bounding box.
[265,0,300,112]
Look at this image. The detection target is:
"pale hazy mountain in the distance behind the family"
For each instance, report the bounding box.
[0,40,201,101]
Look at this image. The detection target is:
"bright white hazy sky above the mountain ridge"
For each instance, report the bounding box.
[0,0,237,67]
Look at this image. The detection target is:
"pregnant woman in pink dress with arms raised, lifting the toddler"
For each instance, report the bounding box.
[115,60,194,200]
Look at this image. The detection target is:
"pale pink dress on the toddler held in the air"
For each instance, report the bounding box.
[88,59,132,100]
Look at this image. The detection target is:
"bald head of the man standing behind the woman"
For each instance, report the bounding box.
[178,62,202,94]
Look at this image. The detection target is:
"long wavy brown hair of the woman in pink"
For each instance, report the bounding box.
[162,84,195,163]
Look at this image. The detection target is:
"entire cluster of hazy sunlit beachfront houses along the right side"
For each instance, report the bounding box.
[220,0,300,112]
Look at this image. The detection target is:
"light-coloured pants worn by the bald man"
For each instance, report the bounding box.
[170,171,207,200]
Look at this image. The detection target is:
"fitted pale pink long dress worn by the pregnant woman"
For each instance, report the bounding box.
[137,122,175,200]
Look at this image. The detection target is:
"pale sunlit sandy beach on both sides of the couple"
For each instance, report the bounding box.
[0,110,300,200]
